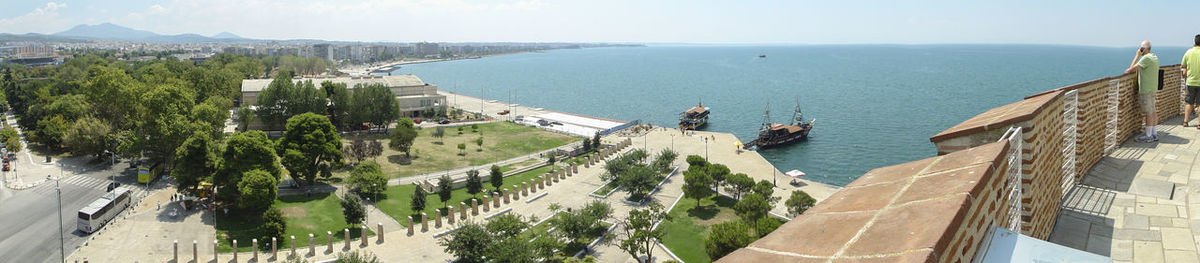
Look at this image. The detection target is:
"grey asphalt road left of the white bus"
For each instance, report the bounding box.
[0,174,127,263]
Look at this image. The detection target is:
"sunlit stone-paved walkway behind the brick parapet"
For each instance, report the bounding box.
[1049,118,1200,262]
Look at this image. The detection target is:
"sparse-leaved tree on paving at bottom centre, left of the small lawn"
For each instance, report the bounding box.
[617,203,671,263]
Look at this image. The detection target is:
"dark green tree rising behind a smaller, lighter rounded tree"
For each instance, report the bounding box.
[212,131,282,203]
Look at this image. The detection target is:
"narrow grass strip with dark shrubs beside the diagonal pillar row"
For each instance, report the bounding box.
[378,166,551,226]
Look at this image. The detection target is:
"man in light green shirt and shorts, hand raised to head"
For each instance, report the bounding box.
[1126,40,1158,143]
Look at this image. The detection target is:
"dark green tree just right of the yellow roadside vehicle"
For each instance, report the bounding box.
[170,132,221,190]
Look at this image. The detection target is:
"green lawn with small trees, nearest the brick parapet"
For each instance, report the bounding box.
[659,195,740,263]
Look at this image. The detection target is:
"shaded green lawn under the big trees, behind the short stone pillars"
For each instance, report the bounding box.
[216,193,373,252]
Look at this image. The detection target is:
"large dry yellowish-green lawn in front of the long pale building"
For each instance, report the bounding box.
[337,121,582,178]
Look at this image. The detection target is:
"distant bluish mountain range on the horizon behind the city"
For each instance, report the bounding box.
[0,23,258,43]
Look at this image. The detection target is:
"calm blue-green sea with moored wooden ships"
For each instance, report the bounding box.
[392,43,1187,186]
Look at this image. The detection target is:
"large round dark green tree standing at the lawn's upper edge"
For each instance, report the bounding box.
[277,113,342,185]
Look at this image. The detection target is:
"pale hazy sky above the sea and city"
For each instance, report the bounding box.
[0,0,1200,46]
